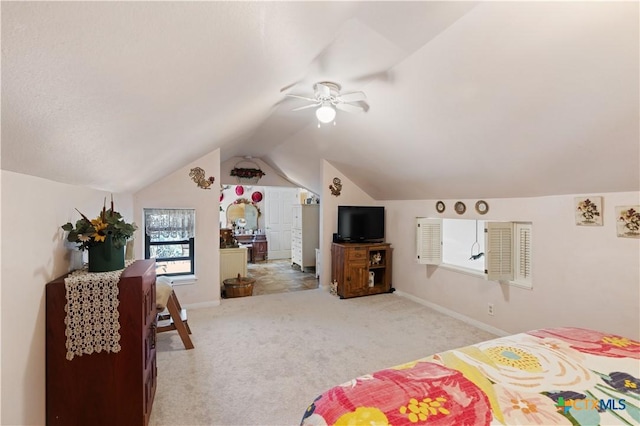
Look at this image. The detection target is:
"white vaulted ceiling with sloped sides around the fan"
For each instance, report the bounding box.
[1,1,640,200]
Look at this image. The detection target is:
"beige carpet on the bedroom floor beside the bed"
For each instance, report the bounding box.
[150,289,495,425]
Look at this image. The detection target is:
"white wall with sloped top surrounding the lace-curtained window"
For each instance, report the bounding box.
[133,149,220,306]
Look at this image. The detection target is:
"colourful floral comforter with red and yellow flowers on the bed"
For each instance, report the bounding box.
[301,328,640,426]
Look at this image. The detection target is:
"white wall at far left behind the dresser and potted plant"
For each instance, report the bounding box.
[0,170,133,425]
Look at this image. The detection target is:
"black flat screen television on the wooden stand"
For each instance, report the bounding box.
[336,206,384,243]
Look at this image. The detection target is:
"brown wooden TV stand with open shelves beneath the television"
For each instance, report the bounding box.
[331,243,392,299]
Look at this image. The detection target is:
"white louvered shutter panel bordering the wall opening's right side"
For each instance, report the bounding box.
[485,222,513,281]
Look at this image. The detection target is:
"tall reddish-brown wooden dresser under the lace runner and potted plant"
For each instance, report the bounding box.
[46,259,157,426]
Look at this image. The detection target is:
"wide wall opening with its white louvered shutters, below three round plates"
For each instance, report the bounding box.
[416,218,532,288]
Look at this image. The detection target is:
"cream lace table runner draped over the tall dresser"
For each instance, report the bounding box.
[64,260,133,361]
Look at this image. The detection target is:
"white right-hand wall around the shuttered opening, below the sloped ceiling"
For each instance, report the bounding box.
[385,192,640,340]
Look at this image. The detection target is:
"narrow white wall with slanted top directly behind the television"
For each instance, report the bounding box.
[320,160,380,288]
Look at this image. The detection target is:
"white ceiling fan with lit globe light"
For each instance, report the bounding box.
[287,81,367,127]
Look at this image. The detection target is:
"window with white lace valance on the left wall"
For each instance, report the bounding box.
[144,209,195,276]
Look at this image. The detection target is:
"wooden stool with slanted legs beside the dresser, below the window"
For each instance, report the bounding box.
[156,277,193,349]
